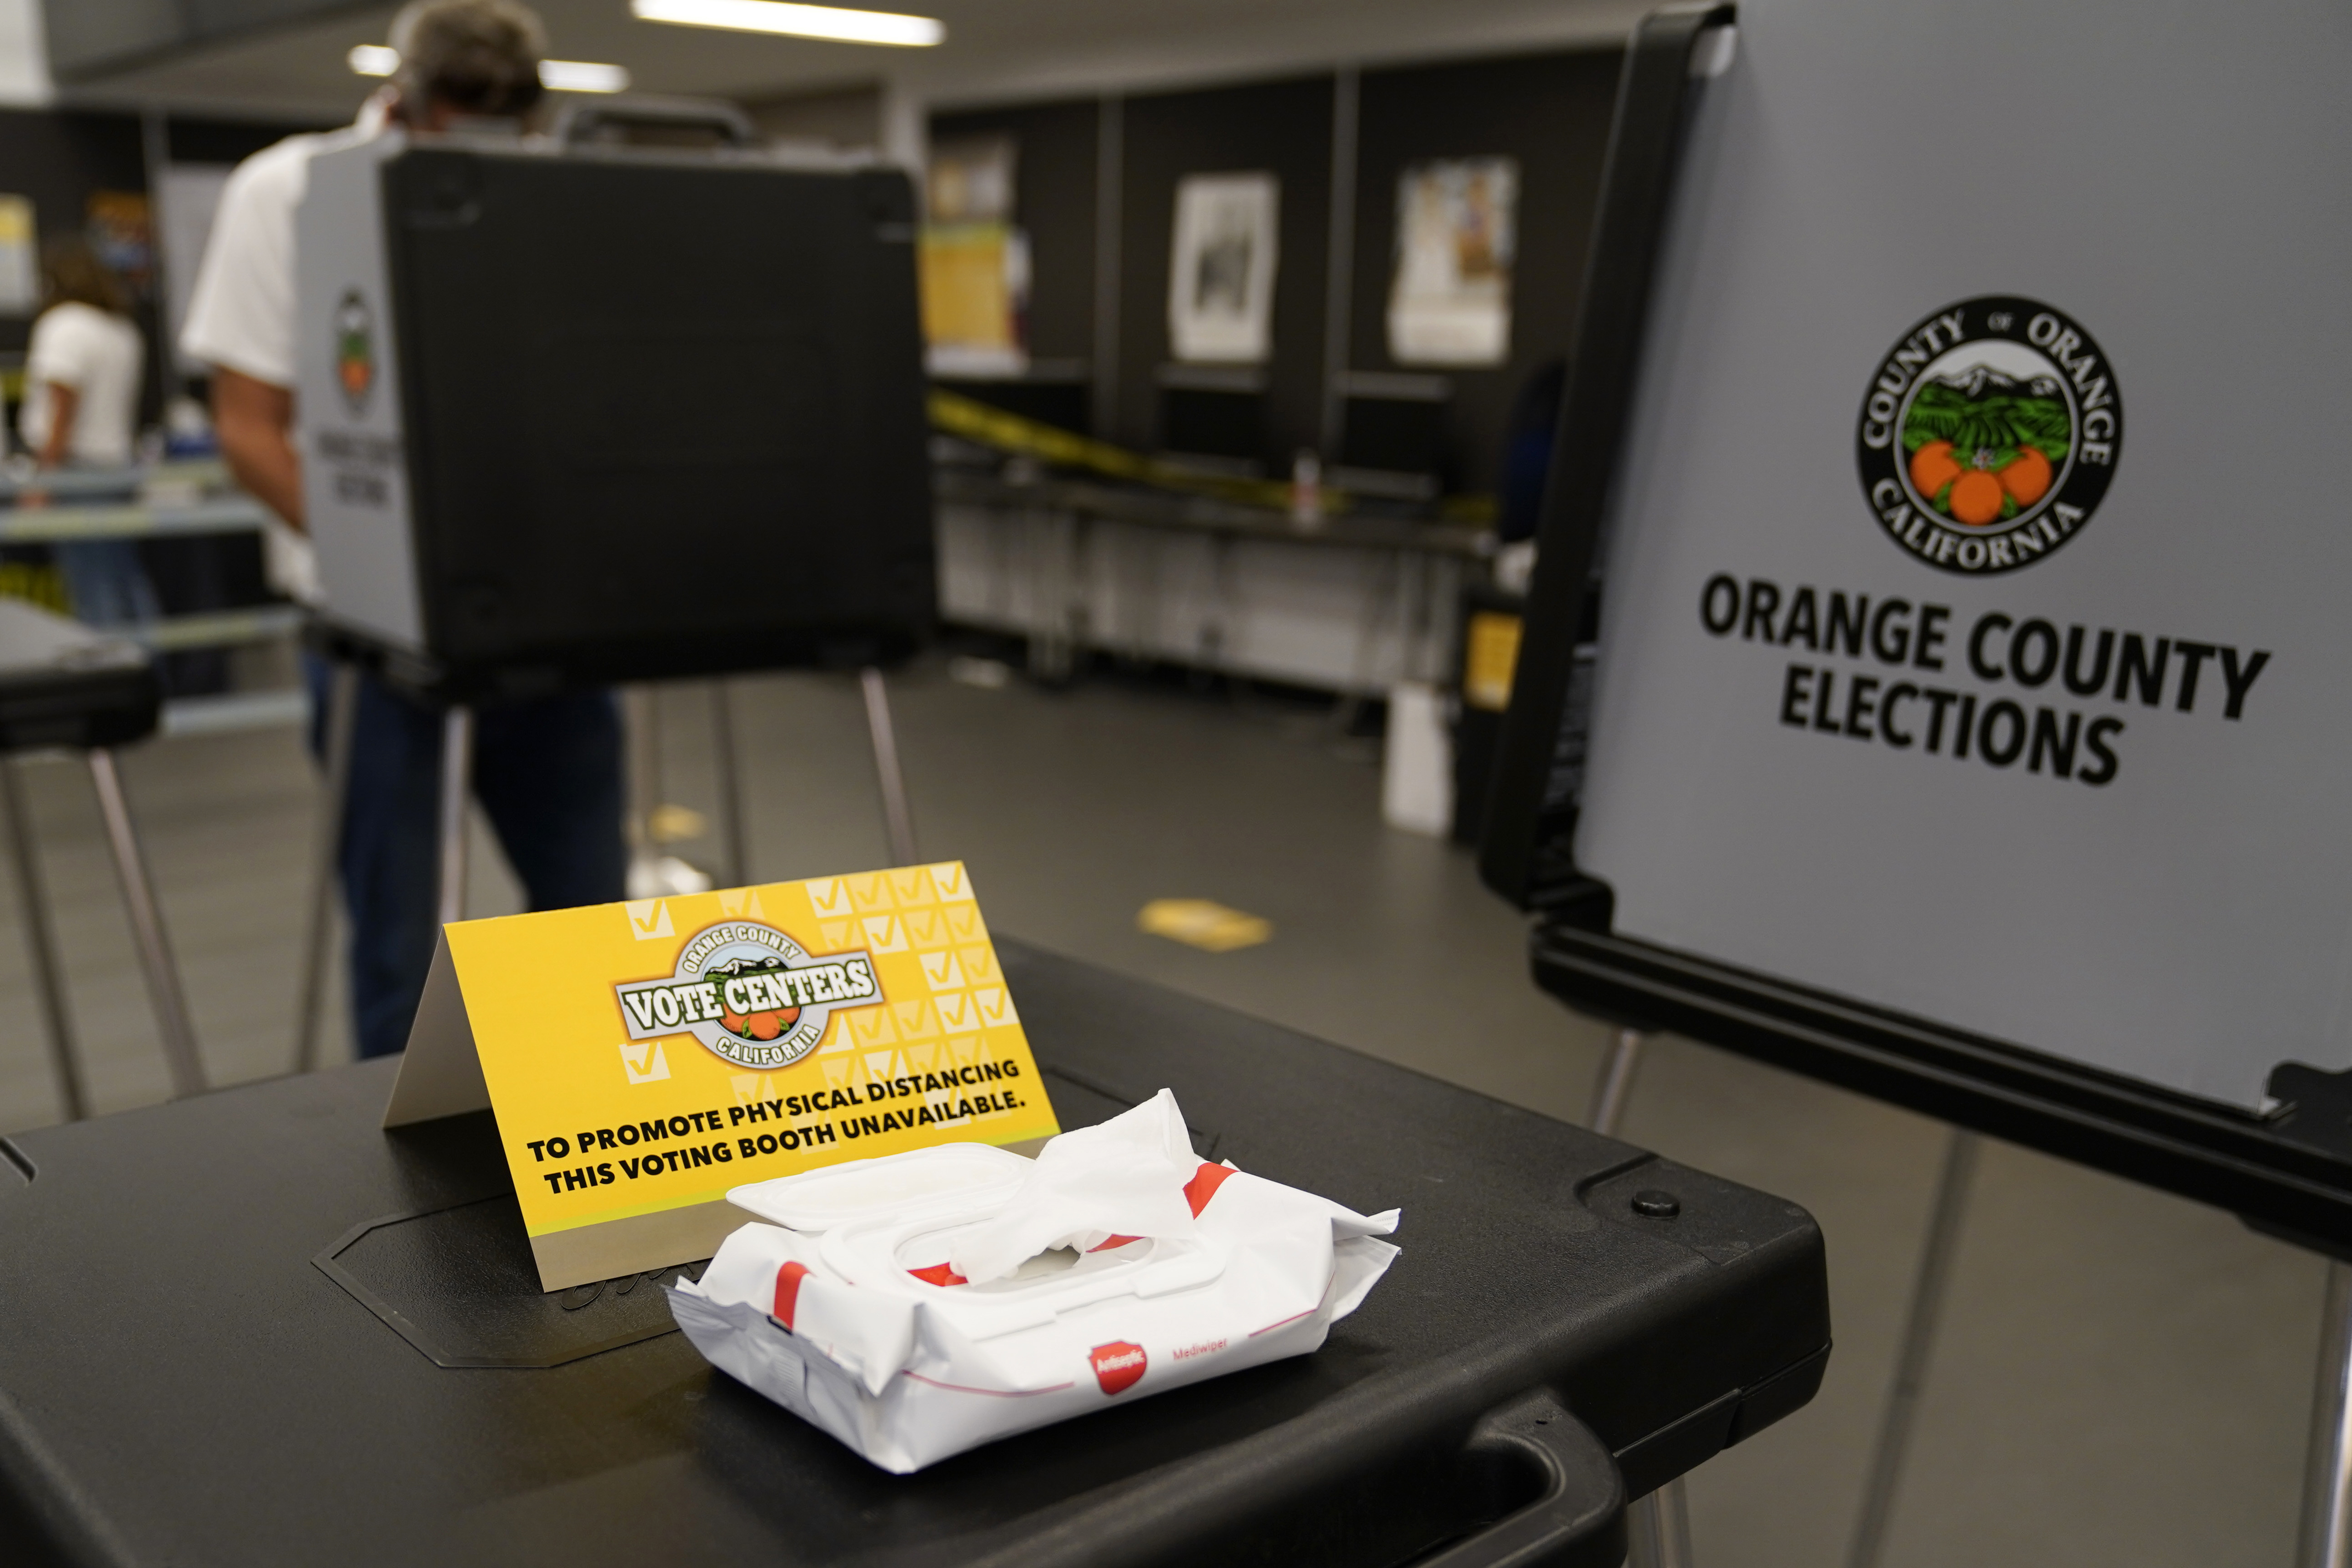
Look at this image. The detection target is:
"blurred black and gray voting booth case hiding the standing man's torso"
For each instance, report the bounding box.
[299,136,934,691]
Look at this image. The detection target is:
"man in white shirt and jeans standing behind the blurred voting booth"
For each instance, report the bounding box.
[181,0,626,1056]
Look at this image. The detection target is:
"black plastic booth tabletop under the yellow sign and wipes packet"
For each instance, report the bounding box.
[0,943,1830,1568]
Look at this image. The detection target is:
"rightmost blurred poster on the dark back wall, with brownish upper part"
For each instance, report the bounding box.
[1388,157,1520,367]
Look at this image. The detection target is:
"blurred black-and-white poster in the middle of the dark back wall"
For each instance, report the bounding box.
[1169,174,1282,364]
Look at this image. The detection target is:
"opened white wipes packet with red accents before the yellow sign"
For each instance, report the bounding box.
[668,1088,1399,1474]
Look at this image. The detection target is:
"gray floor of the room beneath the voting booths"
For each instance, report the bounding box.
[0,670,2322,1568]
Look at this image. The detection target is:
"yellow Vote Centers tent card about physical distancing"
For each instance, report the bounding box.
[383,863,1061,1291]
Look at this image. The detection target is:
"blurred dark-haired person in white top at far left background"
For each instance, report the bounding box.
[16,240,162,625]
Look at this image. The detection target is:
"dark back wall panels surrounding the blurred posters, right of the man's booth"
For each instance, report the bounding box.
[932,50,1623,491]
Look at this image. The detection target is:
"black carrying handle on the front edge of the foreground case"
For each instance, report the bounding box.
[1414,1389,1625,1568]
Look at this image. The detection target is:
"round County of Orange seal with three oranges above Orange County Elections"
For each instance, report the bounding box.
[1853,294,2124,576]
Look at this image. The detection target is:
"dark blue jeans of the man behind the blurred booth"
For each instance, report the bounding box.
[303,654,628,1058]
